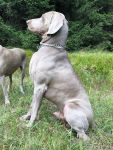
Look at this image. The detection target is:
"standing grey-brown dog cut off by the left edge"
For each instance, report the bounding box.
[0,45,26,104]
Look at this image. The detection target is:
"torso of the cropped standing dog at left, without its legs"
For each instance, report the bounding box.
[0,47,26,76]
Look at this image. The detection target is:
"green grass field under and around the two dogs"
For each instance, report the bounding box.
[0,52,113,150]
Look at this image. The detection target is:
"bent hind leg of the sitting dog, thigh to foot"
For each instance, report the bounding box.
[64,103,89,141]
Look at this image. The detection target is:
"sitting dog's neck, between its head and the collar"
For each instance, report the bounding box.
[40,22,68,48]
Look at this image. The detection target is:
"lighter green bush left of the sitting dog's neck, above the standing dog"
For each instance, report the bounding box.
[0,19,39,51]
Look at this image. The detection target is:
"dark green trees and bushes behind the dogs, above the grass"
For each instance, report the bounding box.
[0,0,113,51]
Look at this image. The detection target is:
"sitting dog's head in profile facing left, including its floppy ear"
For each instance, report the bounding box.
[27,11,67,36]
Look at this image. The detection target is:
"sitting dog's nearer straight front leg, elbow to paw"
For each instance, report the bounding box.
[27,84,47,127]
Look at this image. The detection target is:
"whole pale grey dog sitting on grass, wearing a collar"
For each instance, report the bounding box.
[20,11,93,140]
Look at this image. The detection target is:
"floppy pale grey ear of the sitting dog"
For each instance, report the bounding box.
[47,13,65,35]
